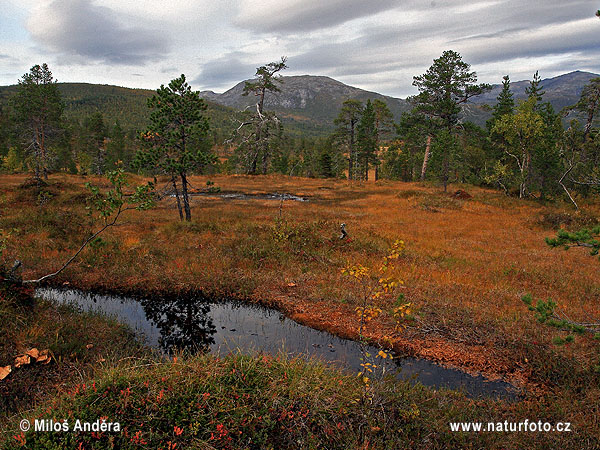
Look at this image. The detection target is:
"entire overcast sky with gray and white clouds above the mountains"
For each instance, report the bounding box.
[0,0,600,97]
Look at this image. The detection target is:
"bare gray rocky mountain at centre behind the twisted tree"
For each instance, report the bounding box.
[200,75,410,135]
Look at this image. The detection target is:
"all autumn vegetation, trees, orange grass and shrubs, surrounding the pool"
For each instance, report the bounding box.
[0,47,600,450]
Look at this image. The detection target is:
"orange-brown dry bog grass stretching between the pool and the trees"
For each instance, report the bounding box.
[0,175,600,381]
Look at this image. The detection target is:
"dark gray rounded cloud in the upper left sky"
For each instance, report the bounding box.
[28,0,169,65]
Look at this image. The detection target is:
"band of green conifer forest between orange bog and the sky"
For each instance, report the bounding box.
[0,51,600,207]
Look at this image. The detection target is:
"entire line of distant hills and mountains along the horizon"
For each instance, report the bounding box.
[0,71,600,136]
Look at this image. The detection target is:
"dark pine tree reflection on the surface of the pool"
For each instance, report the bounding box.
[140,297,217,353]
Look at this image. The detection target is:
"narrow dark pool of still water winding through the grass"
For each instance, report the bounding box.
[37,288,518,399]
